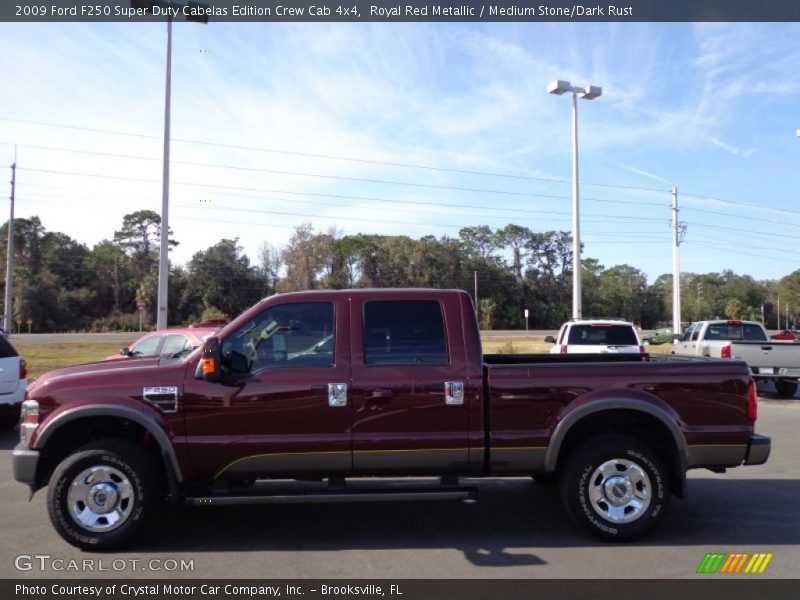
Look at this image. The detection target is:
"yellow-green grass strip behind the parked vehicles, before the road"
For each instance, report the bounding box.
[14,335,672,380]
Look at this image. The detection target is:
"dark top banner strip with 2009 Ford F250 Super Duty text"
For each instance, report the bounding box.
[0,0,800,22]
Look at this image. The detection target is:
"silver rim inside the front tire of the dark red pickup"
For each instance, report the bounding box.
[67,465,134,532]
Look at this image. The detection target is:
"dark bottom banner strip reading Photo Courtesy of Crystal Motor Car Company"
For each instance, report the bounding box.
[0,576,798,600]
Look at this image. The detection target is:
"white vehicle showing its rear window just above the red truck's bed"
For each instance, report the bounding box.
[544,319,644,354]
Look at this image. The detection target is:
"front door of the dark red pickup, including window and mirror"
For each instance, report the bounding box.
[184,297,352,480]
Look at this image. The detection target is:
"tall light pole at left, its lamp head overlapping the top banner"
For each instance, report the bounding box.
[131,0,208,329]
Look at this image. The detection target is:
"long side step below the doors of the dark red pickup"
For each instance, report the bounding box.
[185,488,478,506]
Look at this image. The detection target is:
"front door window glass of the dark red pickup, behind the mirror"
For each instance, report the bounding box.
[222,302,334,372]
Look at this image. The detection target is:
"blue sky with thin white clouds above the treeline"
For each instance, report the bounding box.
[0,22,800,282]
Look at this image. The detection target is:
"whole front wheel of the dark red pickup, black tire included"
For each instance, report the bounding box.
[47,439,164,550]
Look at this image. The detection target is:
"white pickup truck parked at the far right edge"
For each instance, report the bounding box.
[673,320,800,398]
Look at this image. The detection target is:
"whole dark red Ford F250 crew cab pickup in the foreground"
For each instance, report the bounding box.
[13,290,770,550]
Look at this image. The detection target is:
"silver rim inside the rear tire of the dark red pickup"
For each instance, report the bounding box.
[587,458,653,523]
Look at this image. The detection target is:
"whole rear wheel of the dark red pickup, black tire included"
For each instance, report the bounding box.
[559,434,671,542]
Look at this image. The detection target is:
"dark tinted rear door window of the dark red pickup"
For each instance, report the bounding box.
[364,300,449,365]
